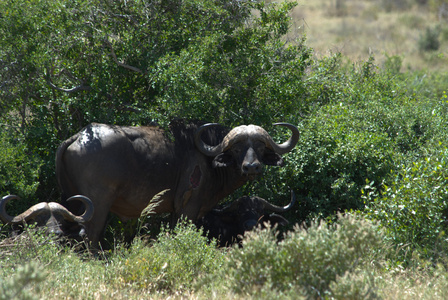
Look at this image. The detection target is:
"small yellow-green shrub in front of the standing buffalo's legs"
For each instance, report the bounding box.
[121,221,223,292]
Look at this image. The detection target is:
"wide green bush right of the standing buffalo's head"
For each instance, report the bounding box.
[247,56,448,222]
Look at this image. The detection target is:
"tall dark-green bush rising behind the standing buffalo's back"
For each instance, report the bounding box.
[0,0,311,133]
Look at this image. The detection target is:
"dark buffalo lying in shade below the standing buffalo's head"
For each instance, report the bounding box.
[197,191,296,247]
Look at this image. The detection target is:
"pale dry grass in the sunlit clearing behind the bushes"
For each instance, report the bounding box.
[291,0,448,71]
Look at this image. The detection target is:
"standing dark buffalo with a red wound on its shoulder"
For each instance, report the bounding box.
[56,121,299,247]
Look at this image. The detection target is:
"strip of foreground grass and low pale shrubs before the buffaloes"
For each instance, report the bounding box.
[0,215,448,299]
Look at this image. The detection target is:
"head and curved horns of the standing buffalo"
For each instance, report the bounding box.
[195,123,300,179]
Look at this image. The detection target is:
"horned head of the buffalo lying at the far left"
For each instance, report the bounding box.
[0,195,94,240]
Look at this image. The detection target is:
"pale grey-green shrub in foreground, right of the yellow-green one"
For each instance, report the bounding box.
[205,216,382,298]
